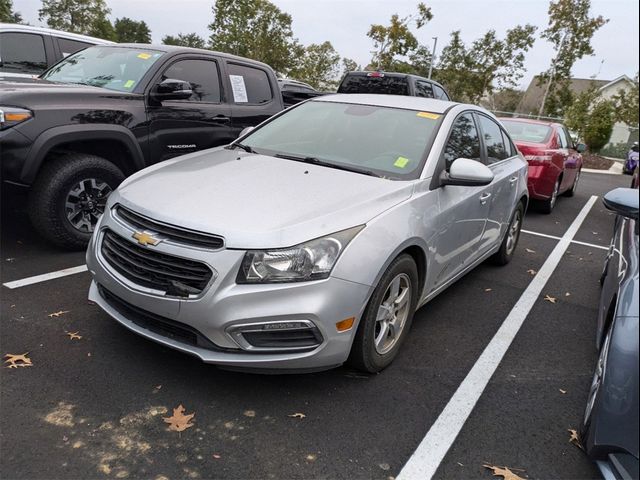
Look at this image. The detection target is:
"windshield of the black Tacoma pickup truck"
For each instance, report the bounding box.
[40,47,162,92]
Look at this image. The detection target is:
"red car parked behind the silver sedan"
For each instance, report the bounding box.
[500,118,587,213]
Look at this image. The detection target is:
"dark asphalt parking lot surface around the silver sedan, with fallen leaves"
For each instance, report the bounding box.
[0,173,629,480]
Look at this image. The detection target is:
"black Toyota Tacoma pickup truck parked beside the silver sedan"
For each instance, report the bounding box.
[0,44,284,248]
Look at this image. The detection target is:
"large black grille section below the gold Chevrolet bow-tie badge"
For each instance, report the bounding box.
[101,230,213,297]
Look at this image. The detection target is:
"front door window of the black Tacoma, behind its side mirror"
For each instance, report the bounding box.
[160,60,220,103]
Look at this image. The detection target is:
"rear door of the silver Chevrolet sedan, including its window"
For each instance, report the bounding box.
[476,113,524,254]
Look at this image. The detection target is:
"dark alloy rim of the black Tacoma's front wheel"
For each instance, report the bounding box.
[65,178,111,233]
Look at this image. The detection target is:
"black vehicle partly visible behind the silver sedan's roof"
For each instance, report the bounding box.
[338,71,451,100]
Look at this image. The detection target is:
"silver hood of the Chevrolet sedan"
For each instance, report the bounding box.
[110,148,413,249]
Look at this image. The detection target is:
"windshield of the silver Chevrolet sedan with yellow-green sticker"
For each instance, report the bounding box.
[242,101,442,180]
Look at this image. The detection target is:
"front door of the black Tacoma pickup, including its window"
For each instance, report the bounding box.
[147,58,235,163]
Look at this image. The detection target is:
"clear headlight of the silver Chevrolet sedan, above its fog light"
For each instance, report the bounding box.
[237,225,364,283]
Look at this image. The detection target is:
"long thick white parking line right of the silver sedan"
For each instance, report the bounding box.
[396,195,598,480]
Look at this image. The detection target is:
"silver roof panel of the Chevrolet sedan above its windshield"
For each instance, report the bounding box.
[311,93,464,113]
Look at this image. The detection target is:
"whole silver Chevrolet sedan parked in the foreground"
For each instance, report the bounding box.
[87,95,528,372]
